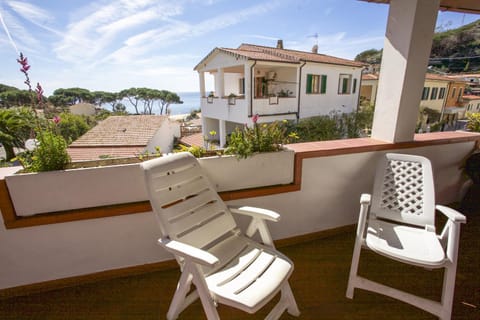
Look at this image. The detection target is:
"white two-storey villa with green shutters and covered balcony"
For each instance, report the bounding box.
[194,40,363,146]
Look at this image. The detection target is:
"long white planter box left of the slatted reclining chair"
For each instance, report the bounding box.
[5,164,148,216]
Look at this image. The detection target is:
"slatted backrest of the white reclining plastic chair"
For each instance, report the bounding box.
[141,152,237,248]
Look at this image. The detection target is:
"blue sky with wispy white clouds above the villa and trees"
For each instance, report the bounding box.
[0,0,480,95]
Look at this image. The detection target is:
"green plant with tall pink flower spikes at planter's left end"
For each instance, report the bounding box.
[13,53,70,172]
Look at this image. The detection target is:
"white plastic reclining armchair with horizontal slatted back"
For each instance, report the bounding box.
[141,153,300,320]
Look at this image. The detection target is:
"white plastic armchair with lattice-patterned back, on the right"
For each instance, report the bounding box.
[346,153,466,319]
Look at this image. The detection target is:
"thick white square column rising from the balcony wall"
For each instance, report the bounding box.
[372,0,440,142]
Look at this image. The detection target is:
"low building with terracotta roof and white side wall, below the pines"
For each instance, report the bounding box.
[68,115,180,162]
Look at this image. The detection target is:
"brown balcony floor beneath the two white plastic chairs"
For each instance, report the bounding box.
[0,195,480,320]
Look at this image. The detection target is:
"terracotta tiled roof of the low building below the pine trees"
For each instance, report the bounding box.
[70,115,168,147]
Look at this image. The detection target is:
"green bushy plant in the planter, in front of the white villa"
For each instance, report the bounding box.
[225,114,298,158]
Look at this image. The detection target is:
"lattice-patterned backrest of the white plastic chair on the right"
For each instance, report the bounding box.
[371,153,435,226]
